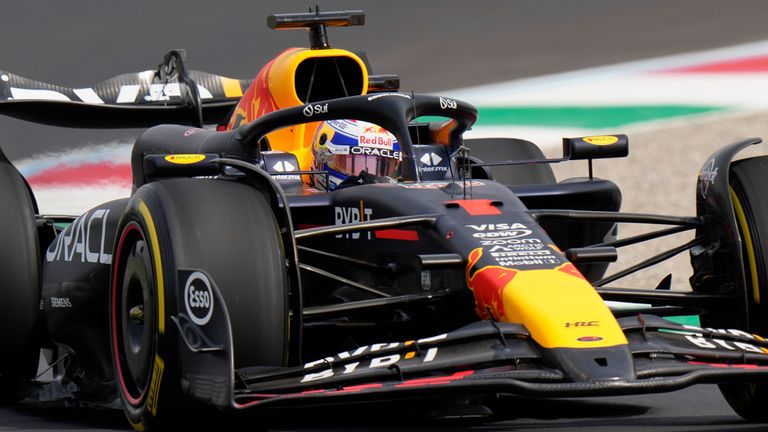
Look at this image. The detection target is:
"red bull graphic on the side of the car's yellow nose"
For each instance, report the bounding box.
[467,248,517,320]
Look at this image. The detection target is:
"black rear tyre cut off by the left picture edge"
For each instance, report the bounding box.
[0,151,40,404]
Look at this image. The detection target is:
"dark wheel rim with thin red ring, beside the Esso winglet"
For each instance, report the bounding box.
[112,223,156,404]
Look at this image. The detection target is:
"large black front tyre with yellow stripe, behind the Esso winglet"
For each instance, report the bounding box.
[110,179,288,430]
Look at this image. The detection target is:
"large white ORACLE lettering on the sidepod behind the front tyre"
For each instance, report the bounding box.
[45,209,112,264]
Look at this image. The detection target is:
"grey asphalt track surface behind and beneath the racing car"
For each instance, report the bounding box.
[0,0,768,431]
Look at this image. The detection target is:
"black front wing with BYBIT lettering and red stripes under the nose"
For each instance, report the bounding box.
[232,315,768,408]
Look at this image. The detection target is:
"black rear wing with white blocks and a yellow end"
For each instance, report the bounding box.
[0,50,251,128]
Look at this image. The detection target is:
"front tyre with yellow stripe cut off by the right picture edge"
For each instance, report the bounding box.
[704,156,768,422]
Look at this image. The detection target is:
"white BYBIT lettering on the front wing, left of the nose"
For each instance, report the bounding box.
[301,333,448,383]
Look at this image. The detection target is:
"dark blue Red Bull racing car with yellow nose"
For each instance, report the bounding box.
[0,10,768,430]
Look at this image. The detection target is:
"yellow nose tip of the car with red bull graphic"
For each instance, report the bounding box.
[467,248,627,348]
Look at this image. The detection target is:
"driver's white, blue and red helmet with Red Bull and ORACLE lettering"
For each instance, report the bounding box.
[312,120,402,190]
